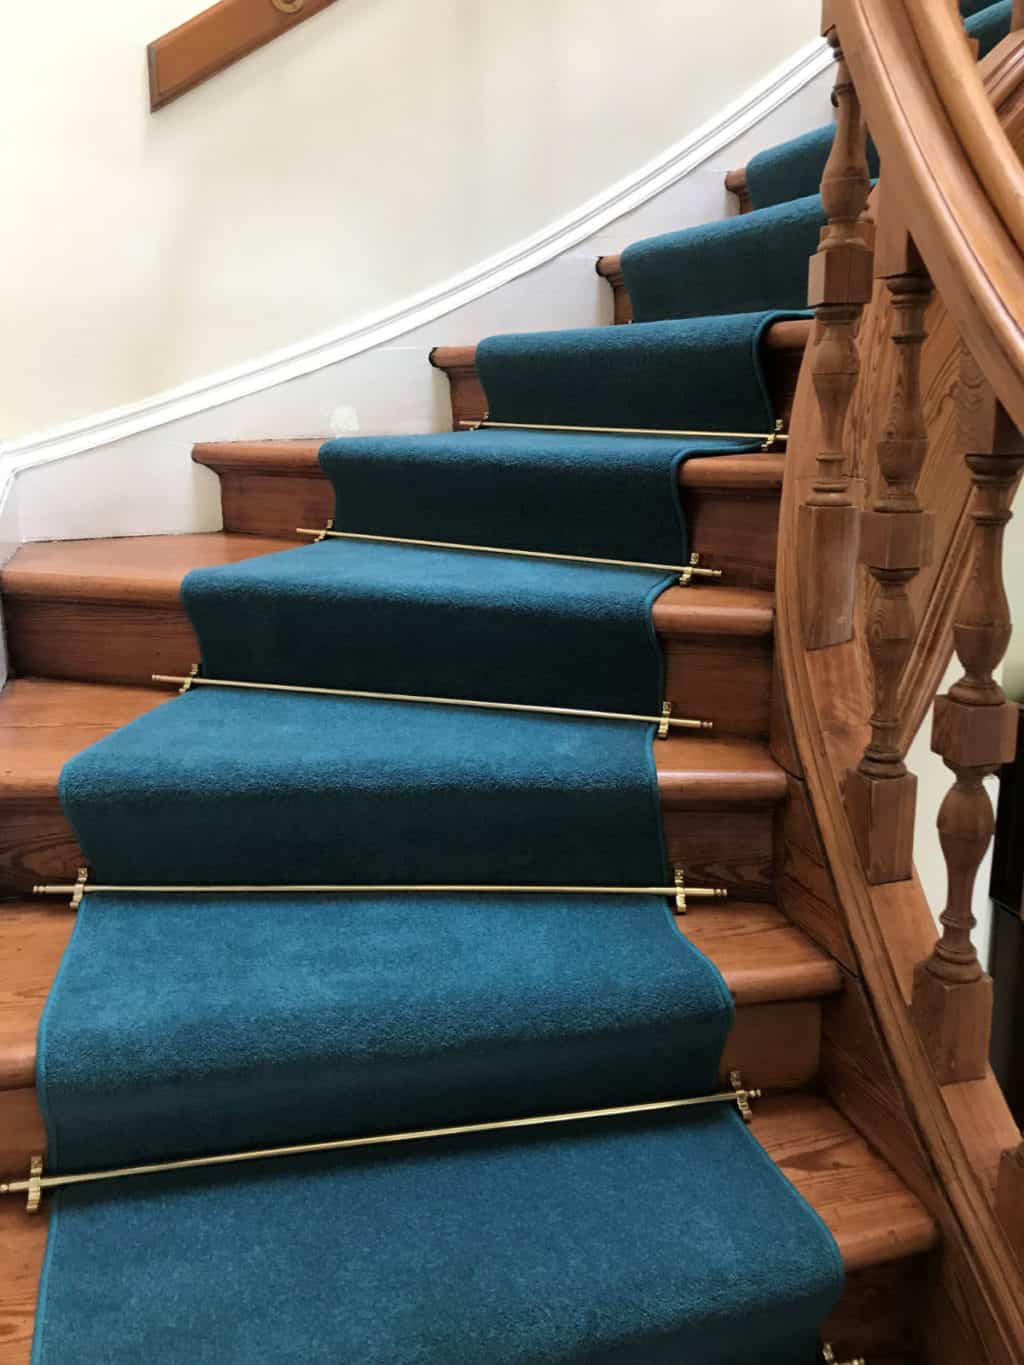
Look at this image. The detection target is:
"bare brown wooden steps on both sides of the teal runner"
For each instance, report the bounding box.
[0,307,937,1365]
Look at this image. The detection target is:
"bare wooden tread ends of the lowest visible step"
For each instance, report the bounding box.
[0,1095,937,1365]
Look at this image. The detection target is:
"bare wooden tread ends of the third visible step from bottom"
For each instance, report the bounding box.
[0,678,786,809]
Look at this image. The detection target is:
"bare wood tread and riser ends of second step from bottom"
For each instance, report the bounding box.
[0,901,841,1174]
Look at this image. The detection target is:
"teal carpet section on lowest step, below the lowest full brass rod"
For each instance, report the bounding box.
[34,1110,841,1365]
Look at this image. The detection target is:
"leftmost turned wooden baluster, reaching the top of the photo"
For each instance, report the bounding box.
[799,0,872,650]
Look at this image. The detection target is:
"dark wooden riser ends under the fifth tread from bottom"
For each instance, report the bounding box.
[195,446,782,587]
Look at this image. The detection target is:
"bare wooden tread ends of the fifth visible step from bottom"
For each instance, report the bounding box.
[193,436,785,490]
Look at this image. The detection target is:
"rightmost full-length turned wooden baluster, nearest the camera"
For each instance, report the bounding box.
[911,398,1024,1085]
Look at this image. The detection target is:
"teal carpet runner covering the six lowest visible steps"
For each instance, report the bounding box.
[34,313,842,1365]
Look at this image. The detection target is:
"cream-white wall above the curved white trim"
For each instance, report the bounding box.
[0,0,827,438]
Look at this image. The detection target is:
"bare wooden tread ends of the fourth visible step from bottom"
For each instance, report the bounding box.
[0,531,774,637]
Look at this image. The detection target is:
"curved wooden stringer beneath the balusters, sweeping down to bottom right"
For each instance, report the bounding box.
[777,229,1024,1365]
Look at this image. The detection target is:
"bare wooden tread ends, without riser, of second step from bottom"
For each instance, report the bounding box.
[0,901,840,1091]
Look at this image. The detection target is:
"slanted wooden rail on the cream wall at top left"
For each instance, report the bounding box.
[146,0,341,112]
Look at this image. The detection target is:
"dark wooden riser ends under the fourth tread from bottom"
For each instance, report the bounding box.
[3,591,771,736]
